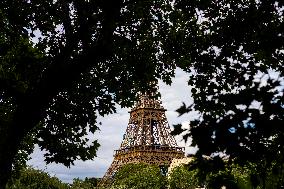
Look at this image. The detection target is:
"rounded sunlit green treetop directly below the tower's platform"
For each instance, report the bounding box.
[112,163,167,189]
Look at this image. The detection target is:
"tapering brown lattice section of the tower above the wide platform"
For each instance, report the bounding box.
[120,94,177,149]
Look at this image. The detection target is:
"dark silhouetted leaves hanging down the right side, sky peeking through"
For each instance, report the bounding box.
[171,0,284,168]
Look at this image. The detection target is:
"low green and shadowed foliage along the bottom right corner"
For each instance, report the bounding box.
[178,156,283,189]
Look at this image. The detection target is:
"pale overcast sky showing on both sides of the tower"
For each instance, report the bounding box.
[28,70,199,183]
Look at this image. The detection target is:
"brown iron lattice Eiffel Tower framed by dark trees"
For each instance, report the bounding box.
[99,94,184,186]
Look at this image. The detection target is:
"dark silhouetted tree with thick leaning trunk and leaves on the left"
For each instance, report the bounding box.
[0,0,175,188]
